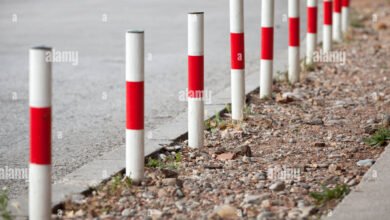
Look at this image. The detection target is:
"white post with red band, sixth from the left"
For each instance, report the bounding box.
[288,0,300,83]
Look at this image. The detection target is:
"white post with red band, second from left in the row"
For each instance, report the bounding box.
[126,30,145,182]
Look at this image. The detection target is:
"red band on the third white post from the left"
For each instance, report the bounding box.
[188,56,204,98]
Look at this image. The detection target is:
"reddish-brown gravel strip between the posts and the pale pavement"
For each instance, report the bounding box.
[59,0,390,219]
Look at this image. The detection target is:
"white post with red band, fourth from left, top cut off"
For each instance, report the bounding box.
[230,0,245,120]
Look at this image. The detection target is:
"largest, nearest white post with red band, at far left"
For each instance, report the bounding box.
[29,47,52,220]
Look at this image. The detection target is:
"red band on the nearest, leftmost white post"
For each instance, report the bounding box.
[30,107,51,165]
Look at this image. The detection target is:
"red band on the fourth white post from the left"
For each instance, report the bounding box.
[230,33,245,70]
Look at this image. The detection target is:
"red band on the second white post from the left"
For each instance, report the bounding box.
[126,82,144,130]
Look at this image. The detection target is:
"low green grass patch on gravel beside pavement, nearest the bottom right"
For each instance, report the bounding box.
[310,184,350,205]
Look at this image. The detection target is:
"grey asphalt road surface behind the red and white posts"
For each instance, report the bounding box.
[0,0,306,197]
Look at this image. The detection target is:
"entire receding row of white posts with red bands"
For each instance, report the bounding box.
[29,0,349,220]
